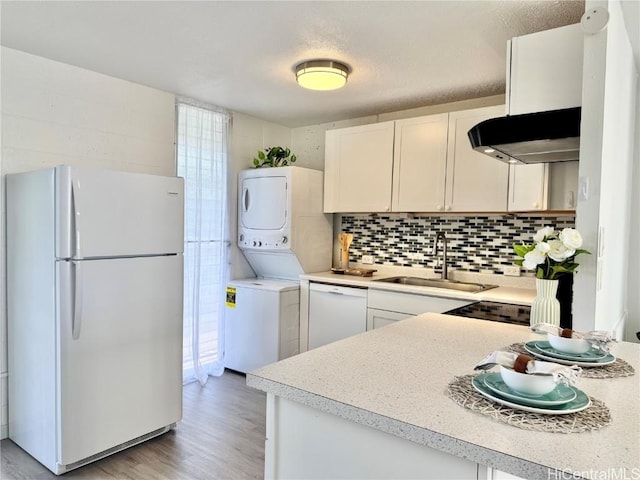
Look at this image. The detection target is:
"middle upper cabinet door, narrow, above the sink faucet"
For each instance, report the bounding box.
[392,113,449,212]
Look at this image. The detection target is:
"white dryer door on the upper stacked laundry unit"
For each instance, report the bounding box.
[238,176,287,231]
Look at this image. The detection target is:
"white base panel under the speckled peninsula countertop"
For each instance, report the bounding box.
[264,393,486,480]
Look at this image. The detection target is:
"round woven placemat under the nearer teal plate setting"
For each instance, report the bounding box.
[447,375,611,433]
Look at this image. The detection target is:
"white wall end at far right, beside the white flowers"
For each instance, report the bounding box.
[574,1,638,338]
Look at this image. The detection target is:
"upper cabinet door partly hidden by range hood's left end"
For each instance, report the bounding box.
[445,105,509,212]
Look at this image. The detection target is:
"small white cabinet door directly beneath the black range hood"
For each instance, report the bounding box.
[509,163,549,212]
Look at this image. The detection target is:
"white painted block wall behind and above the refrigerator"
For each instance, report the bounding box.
[0,47,175,438]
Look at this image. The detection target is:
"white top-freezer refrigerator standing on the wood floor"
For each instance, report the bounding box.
[6,166,184,474]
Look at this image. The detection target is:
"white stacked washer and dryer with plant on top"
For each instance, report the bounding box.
[224,167,333,373]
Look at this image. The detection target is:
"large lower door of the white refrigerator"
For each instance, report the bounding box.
[57,255,182,465]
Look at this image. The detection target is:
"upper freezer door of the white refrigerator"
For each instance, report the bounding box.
[55,166,184,259]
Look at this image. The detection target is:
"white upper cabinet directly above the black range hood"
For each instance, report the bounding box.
[507,23,584,115]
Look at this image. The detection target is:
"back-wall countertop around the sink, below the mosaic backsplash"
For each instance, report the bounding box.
[300,272,536,305]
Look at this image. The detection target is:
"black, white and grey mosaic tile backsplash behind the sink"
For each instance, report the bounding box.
[341,215,575,274]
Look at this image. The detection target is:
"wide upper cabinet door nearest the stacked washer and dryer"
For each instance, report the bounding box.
[324,121,394,213]
